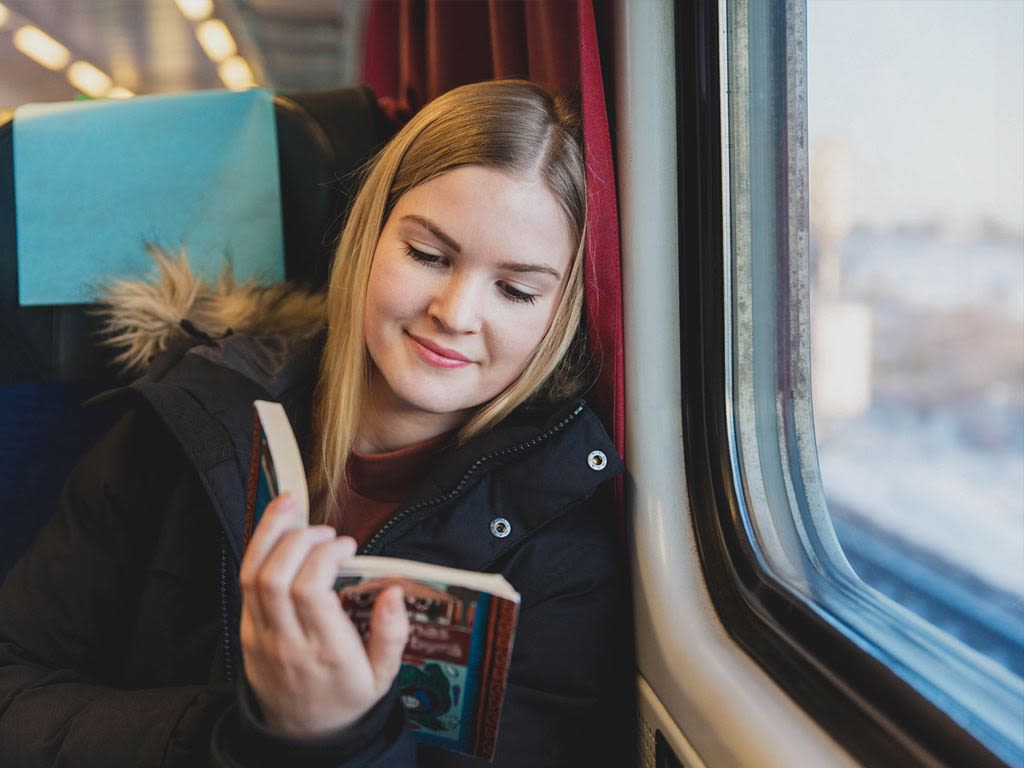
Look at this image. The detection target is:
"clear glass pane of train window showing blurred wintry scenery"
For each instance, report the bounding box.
[808,0,1024,676]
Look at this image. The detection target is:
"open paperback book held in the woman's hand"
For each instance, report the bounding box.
[245,400,519,760]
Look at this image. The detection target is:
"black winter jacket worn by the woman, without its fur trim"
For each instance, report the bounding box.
[0,336,634,768]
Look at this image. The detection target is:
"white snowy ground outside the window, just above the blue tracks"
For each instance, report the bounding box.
[818,409,1024,598]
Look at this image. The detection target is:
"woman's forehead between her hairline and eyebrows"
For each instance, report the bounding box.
[391,166,575,271]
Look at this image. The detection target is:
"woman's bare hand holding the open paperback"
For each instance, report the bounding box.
[240,495,409,736]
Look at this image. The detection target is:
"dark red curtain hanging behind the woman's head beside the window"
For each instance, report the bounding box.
[362,0,625,509]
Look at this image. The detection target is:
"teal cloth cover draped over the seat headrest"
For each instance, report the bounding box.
[13,90,285,305]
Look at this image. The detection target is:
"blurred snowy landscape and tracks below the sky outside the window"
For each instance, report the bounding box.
[812,217,1024,676]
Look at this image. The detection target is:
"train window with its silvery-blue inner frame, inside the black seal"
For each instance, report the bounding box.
[723,0,1024,764]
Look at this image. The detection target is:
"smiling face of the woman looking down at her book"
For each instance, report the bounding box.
[364,166,574,430]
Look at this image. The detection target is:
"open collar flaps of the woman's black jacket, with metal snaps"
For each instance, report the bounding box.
[117,335,622,569]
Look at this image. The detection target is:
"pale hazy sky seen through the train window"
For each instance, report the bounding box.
[807,0,1024,234]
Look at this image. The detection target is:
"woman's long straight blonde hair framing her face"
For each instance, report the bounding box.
[311,80,587,521]
